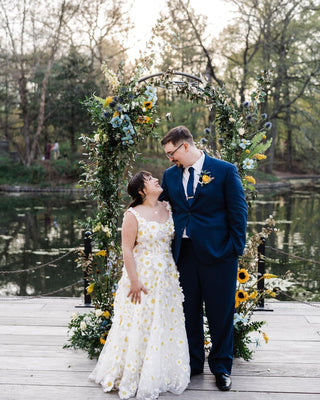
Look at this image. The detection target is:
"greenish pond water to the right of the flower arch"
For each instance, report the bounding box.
[249,186,320,301]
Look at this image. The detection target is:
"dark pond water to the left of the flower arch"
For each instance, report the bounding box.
[0,194,94,296]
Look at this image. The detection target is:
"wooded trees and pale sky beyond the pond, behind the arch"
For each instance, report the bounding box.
[0,0,320,185]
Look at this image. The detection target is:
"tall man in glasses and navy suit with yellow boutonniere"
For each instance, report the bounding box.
[160,126,247,390]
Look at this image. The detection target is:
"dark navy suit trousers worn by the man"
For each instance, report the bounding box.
[177,239,238,374]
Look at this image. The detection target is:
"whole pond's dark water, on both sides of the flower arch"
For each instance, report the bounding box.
[0,186,320,301]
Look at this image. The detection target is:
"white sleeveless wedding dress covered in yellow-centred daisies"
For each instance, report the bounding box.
[89,204,190,400]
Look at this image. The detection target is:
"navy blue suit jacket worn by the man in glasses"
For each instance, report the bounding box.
[159,154,248,264]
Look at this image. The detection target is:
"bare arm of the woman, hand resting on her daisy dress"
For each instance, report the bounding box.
[121,212,148,303]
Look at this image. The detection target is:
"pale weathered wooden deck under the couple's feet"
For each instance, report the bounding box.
[0,298,320,400]
